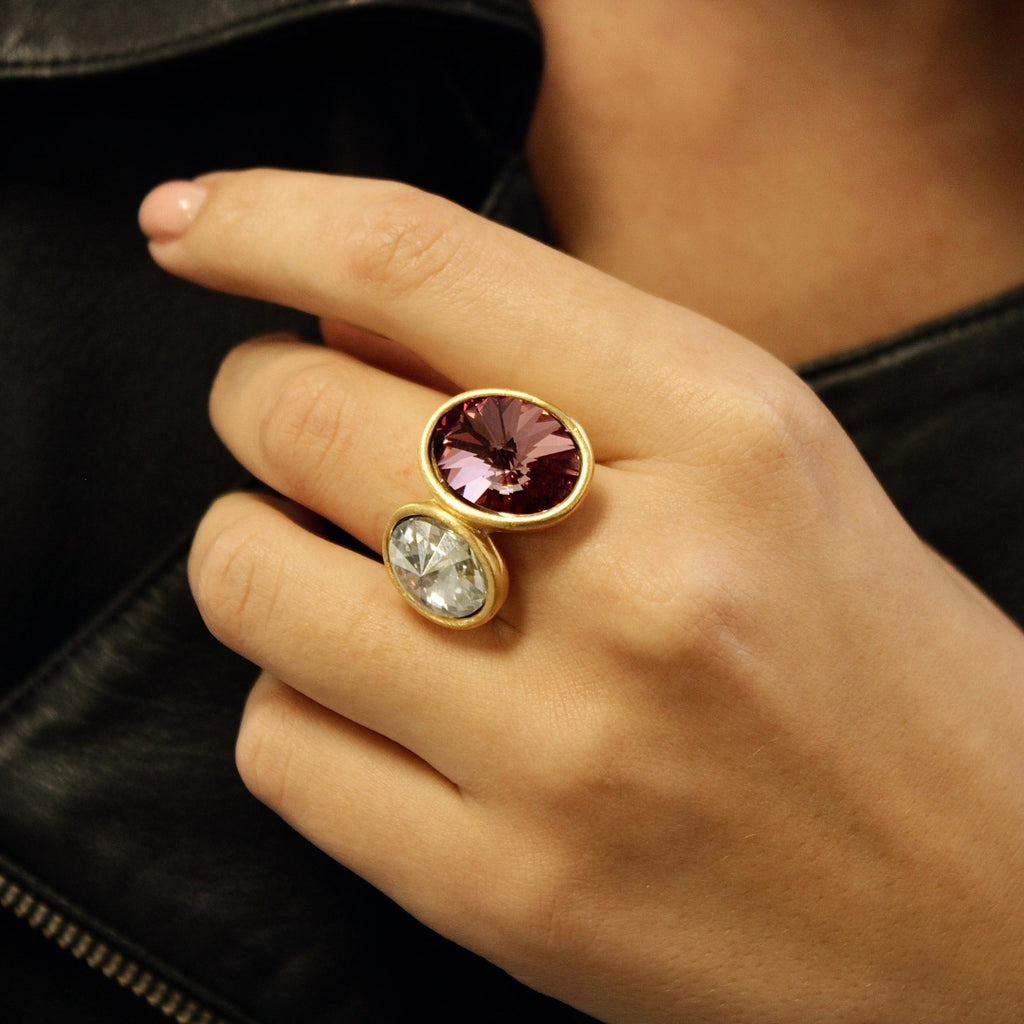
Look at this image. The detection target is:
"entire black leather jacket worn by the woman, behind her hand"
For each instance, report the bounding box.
[0,0,1024,1024]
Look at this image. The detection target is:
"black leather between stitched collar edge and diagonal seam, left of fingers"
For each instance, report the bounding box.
[0,0,540,691]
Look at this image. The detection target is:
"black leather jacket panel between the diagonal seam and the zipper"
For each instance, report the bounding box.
[0,540,568,1024]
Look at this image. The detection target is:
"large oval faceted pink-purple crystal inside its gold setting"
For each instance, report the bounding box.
[431,394,580,515]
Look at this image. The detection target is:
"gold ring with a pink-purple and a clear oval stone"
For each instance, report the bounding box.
[383,390,594,629]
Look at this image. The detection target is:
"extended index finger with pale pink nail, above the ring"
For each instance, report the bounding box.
[140,171,734,458]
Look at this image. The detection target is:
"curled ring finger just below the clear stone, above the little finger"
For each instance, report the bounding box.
[188,494,532,778]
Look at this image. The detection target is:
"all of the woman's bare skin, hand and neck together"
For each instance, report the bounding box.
[140,0,1024,1024]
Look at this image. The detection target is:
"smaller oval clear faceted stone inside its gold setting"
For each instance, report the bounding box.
[388,515,487,618]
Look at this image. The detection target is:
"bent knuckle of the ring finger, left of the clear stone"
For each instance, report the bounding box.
[189,507,280,650]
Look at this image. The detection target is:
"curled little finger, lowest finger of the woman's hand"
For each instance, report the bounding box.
[236,674,542,956]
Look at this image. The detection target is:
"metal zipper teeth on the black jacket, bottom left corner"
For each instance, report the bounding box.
[0,872,229,1024]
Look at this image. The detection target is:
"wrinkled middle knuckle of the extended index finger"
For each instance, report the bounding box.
[347,186,464,297]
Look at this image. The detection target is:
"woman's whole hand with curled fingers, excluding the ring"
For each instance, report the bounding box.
[141,171,1024,1024]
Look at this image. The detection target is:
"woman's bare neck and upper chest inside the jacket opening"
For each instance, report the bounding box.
[529,0,1024,364]
